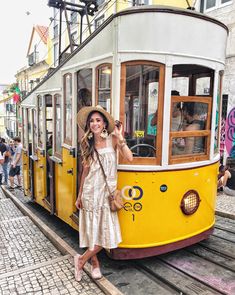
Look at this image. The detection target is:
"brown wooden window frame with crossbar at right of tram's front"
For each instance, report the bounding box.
[169,96,213,164]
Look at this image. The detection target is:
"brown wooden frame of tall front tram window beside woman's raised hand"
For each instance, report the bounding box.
[119,60,165,165]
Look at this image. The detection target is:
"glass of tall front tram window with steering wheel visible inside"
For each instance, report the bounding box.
[121,62,162,164]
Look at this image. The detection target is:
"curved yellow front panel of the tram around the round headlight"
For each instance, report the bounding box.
[118,163,218,248]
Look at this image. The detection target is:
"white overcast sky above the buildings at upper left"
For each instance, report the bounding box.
[0,0,53,84]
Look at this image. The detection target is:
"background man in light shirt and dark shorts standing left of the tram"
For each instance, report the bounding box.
[8,136,22,190]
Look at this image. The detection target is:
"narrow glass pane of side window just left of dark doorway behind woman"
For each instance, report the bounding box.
[64,74,73,145]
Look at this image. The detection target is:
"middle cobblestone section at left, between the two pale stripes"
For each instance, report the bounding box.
[0,217,62,276]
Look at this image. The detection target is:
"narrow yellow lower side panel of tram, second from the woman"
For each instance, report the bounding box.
[34,150,49,210]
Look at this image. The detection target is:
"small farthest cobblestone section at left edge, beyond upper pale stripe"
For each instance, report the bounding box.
[0,199,24,222]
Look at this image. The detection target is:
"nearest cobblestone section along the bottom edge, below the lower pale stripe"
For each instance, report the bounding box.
[0,259,104,295]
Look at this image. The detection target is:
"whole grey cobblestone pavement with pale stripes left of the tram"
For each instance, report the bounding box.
[0,191,103,295]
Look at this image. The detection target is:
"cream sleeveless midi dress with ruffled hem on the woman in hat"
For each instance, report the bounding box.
[79,136,122,250]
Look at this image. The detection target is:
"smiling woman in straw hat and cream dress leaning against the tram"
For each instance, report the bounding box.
[74,106,133,281]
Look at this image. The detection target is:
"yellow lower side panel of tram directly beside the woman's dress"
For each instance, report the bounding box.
[55,148,77,228]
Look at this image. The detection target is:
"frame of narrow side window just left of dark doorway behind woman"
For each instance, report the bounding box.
[63,73,73,146]
